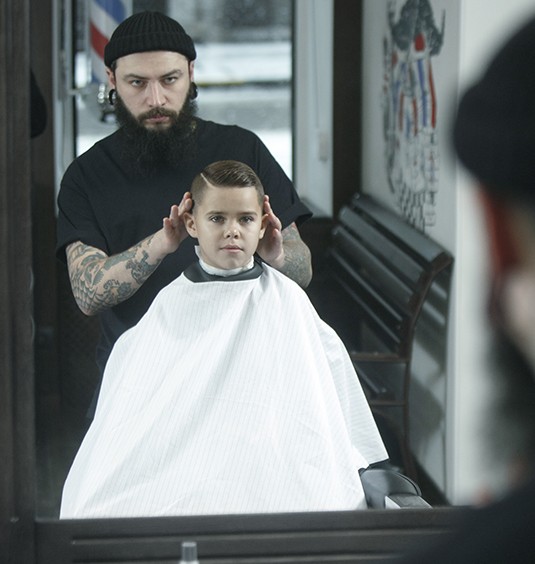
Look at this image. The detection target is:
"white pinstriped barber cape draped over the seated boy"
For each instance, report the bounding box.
[60,264,388,519]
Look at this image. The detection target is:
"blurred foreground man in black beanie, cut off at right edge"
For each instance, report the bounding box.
[409,15,535,564]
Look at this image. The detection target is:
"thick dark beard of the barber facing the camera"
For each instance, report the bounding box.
[115,92,197,174]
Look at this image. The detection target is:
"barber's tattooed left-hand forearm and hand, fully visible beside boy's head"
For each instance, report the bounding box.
[66,196,191,315]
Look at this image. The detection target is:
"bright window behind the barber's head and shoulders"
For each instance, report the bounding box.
[75,0,293,178]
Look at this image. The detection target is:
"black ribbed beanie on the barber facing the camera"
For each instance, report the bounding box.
[104,12,197,67]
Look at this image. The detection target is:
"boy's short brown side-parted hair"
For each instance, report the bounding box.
[191,160,264,209]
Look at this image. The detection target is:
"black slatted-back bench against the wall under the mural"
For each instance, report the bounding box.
[308,195,453,478]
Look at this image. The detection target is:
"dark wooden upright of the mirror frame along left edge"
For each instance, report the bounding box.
[0,0,35,562]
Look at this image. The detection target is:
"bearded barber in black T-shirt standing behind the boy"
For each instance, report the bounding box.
[57,12,311,386]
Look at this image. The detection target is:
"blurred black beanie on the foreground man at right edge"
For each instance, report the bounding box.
[453,19,535,201]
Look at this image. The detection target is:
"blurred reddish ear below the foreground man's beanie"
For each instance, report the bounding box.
[479,188,519,280]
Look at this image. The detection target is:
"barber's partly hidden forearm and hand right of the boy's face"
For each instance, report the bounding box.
[258,196,312,288]
